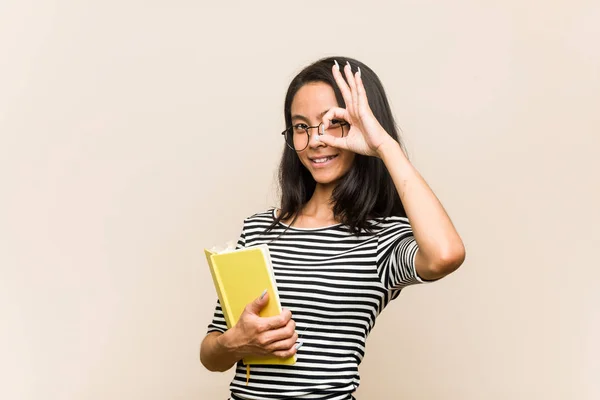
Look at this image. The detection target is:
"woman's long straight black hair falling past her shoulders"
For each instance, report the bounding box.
[268,57,406,234]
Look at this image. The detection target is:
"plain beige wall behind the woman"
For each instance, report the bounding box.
[0,0,600,400]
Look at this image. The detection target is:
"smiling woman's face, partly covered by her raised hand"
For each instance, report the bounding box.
[291,82,355,185]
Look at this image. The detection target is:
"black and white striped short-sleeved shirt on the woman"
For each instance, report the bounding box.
[208,209,423,400]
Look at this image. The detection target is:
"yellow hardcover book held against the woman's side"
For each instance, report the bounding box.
[204,244,296,365]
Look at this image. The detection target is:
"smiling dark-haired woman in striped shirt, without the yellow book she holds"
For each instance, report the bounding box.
[200,57,465,399]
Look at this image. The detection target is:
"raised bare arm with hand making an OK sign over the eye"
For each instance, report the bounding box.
[318,63,465,280]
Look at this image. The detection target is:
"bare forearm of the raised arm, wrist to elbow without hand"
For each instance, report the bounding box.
[379,140,464,279]
